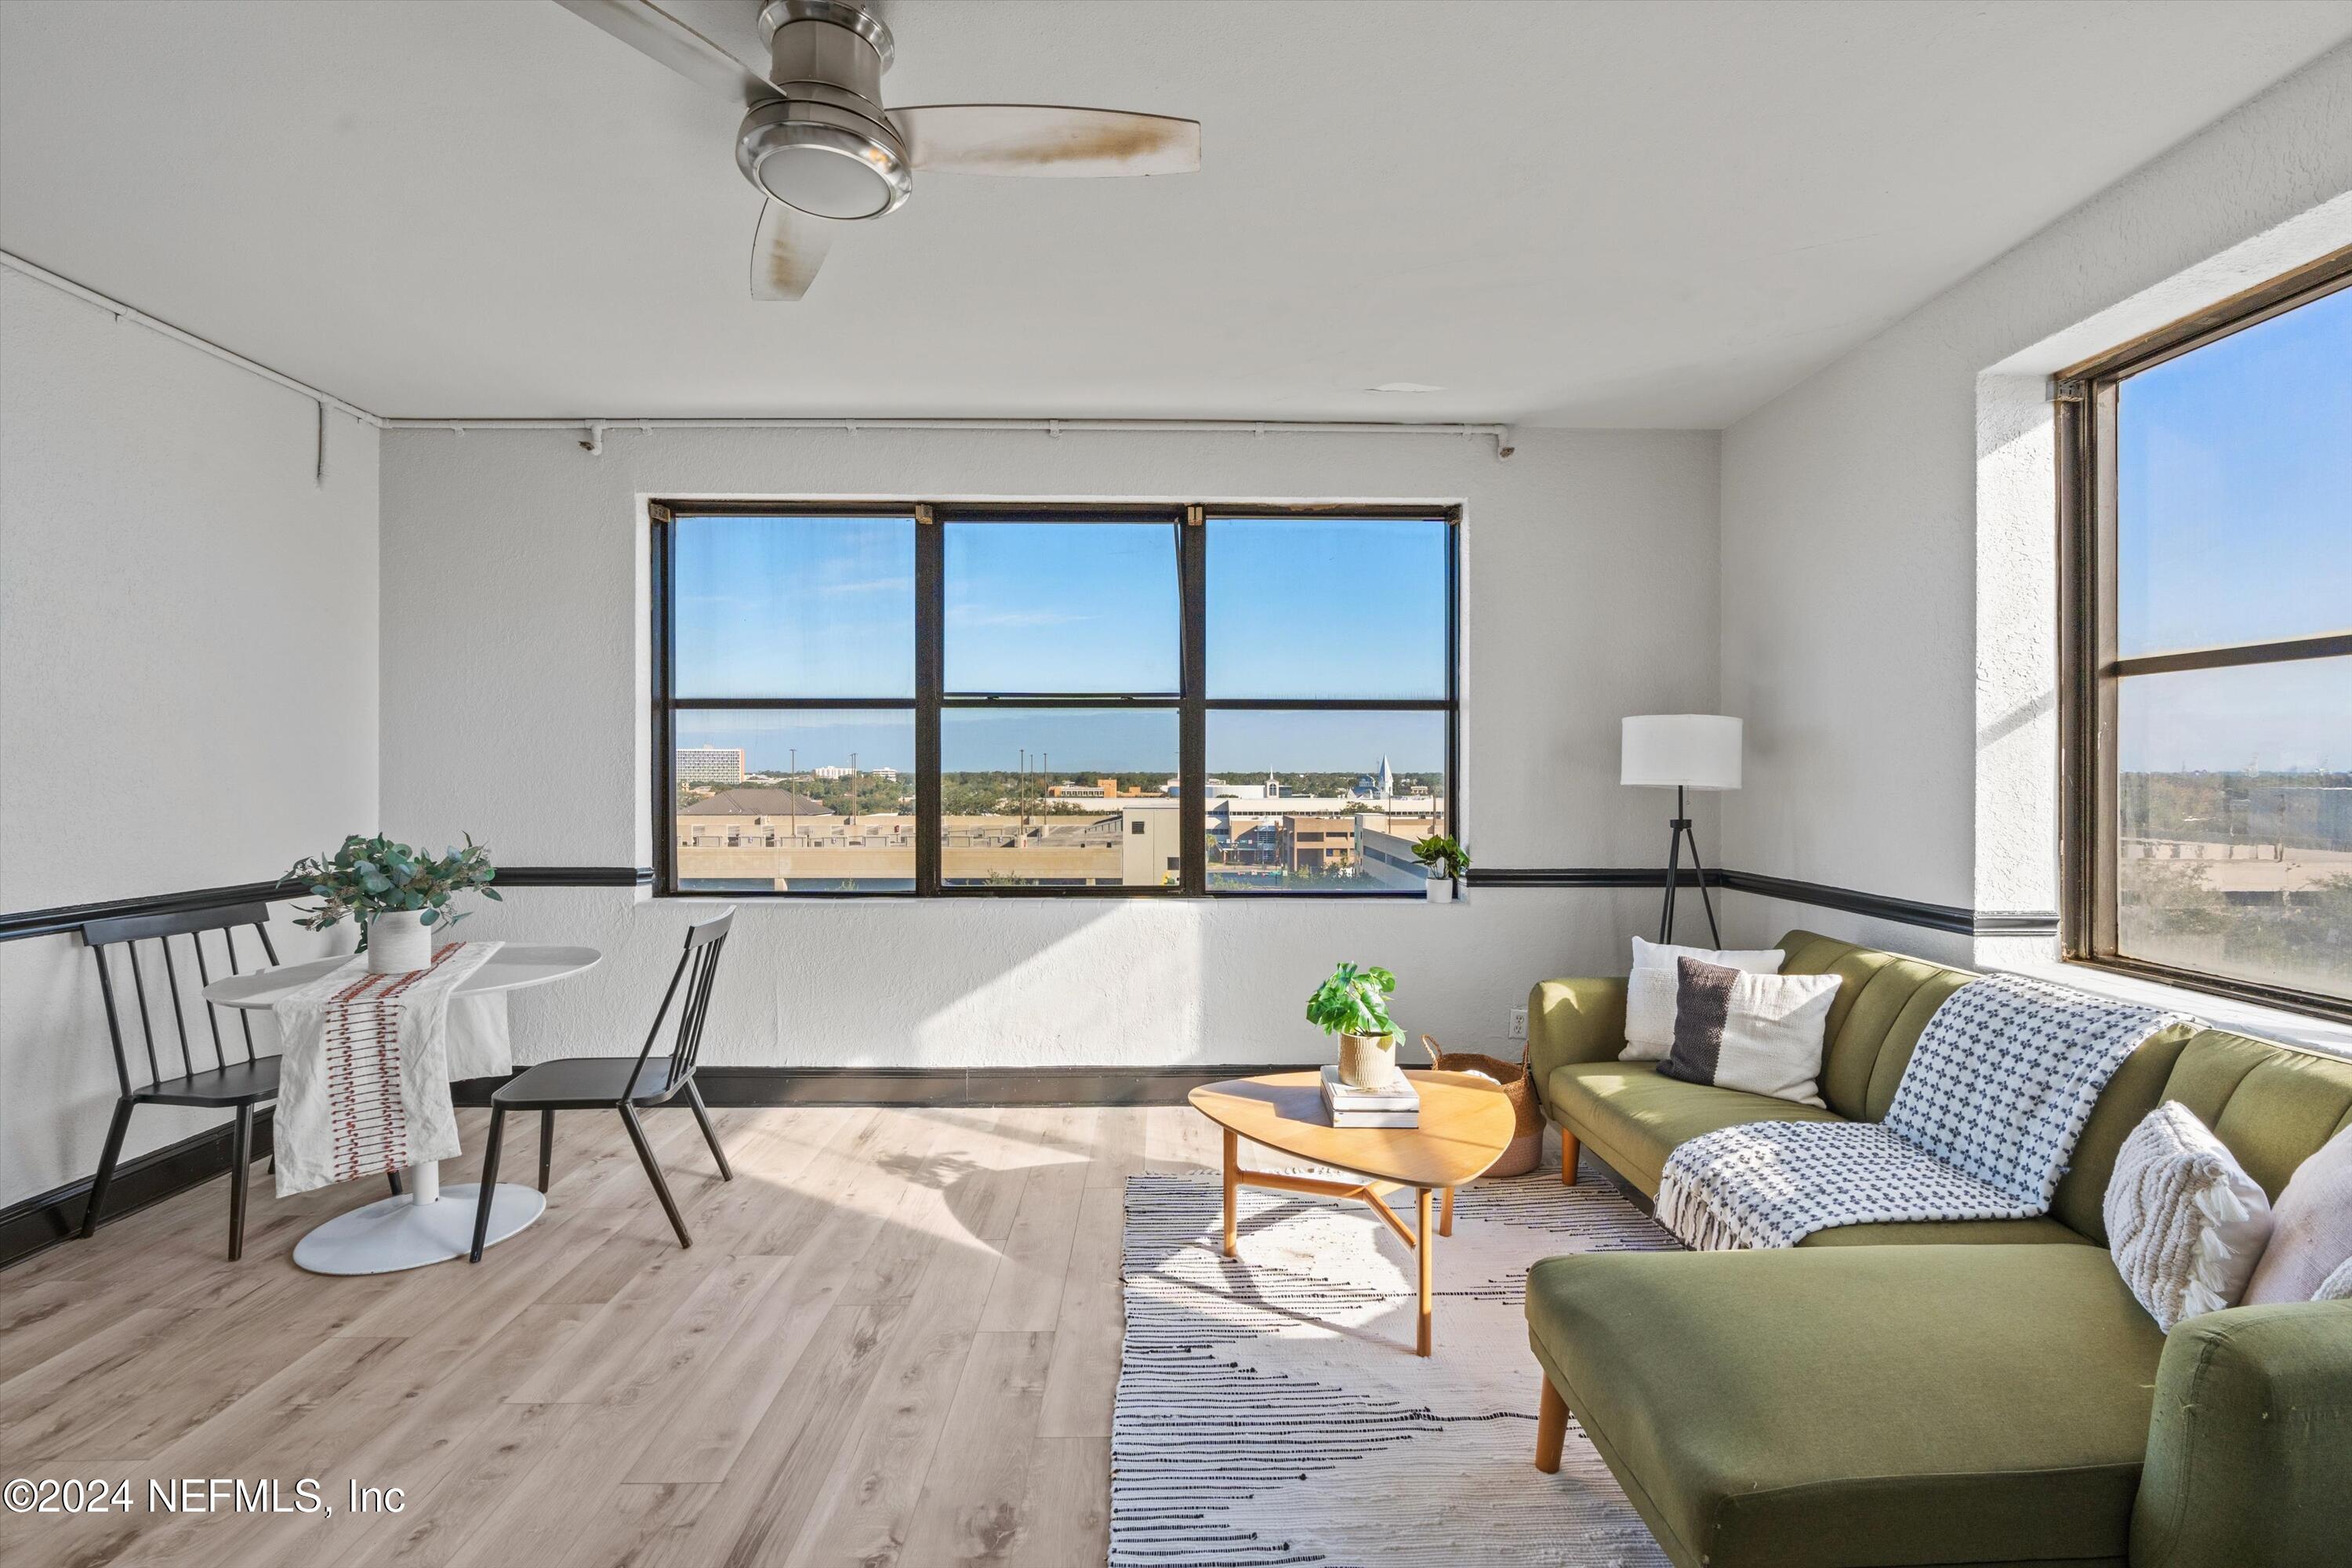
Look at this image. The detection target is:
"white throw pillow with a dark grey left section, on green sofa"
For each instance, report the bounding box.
[1658,959,1837,1105]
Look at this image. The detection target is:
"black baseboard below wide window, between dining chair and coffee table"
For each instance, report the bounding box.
[694,1062,1310,1107]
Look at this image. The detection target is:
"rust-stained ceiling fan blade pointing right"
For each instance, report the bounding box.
[889,103,1200,179]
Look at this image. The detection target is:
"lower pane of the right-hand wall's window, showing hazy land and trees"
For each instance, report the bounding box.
[2114,659,2352,996]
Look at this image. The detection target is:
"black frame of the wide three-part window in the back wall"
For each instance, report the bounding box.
[647,499,1463,902]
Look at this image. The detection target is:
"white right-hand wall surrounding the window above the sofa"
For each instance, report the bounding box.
[1722,47,2352,961]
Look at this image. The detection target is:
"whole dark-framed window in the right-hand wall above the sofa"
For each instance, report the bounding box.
[2060,256,2352,1015]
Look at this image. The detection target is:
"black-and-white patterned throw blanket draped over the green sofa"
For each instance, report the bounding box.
[1658,975,2183,1248]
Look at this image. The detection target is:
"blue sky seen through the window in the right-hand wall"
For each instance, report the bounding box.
[2117,289,2352,771]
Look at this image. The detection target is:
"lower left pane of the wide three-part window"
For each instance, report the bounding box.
[673,710,915,893]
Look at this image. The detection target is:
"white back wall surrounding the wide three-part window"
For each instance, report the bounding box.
[383,430,1717,1067]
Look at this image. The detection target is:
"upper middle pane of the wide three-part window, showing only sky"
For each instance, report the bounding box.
[946,522,1181,696]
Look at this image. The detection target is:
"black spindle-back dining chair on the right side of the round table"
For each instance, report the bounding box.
[470,909,734,1262]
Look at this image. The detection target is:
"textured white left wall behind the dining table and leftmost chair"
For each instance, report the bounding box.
[0,270,379,1206]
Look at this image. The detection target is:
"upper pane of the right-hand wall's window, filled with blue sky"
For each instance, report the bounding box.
[2114,289,2352,659]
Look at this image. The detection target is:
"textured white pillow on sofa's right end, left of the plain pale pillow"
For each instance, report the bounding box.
[2105,1100,2270,1333]
